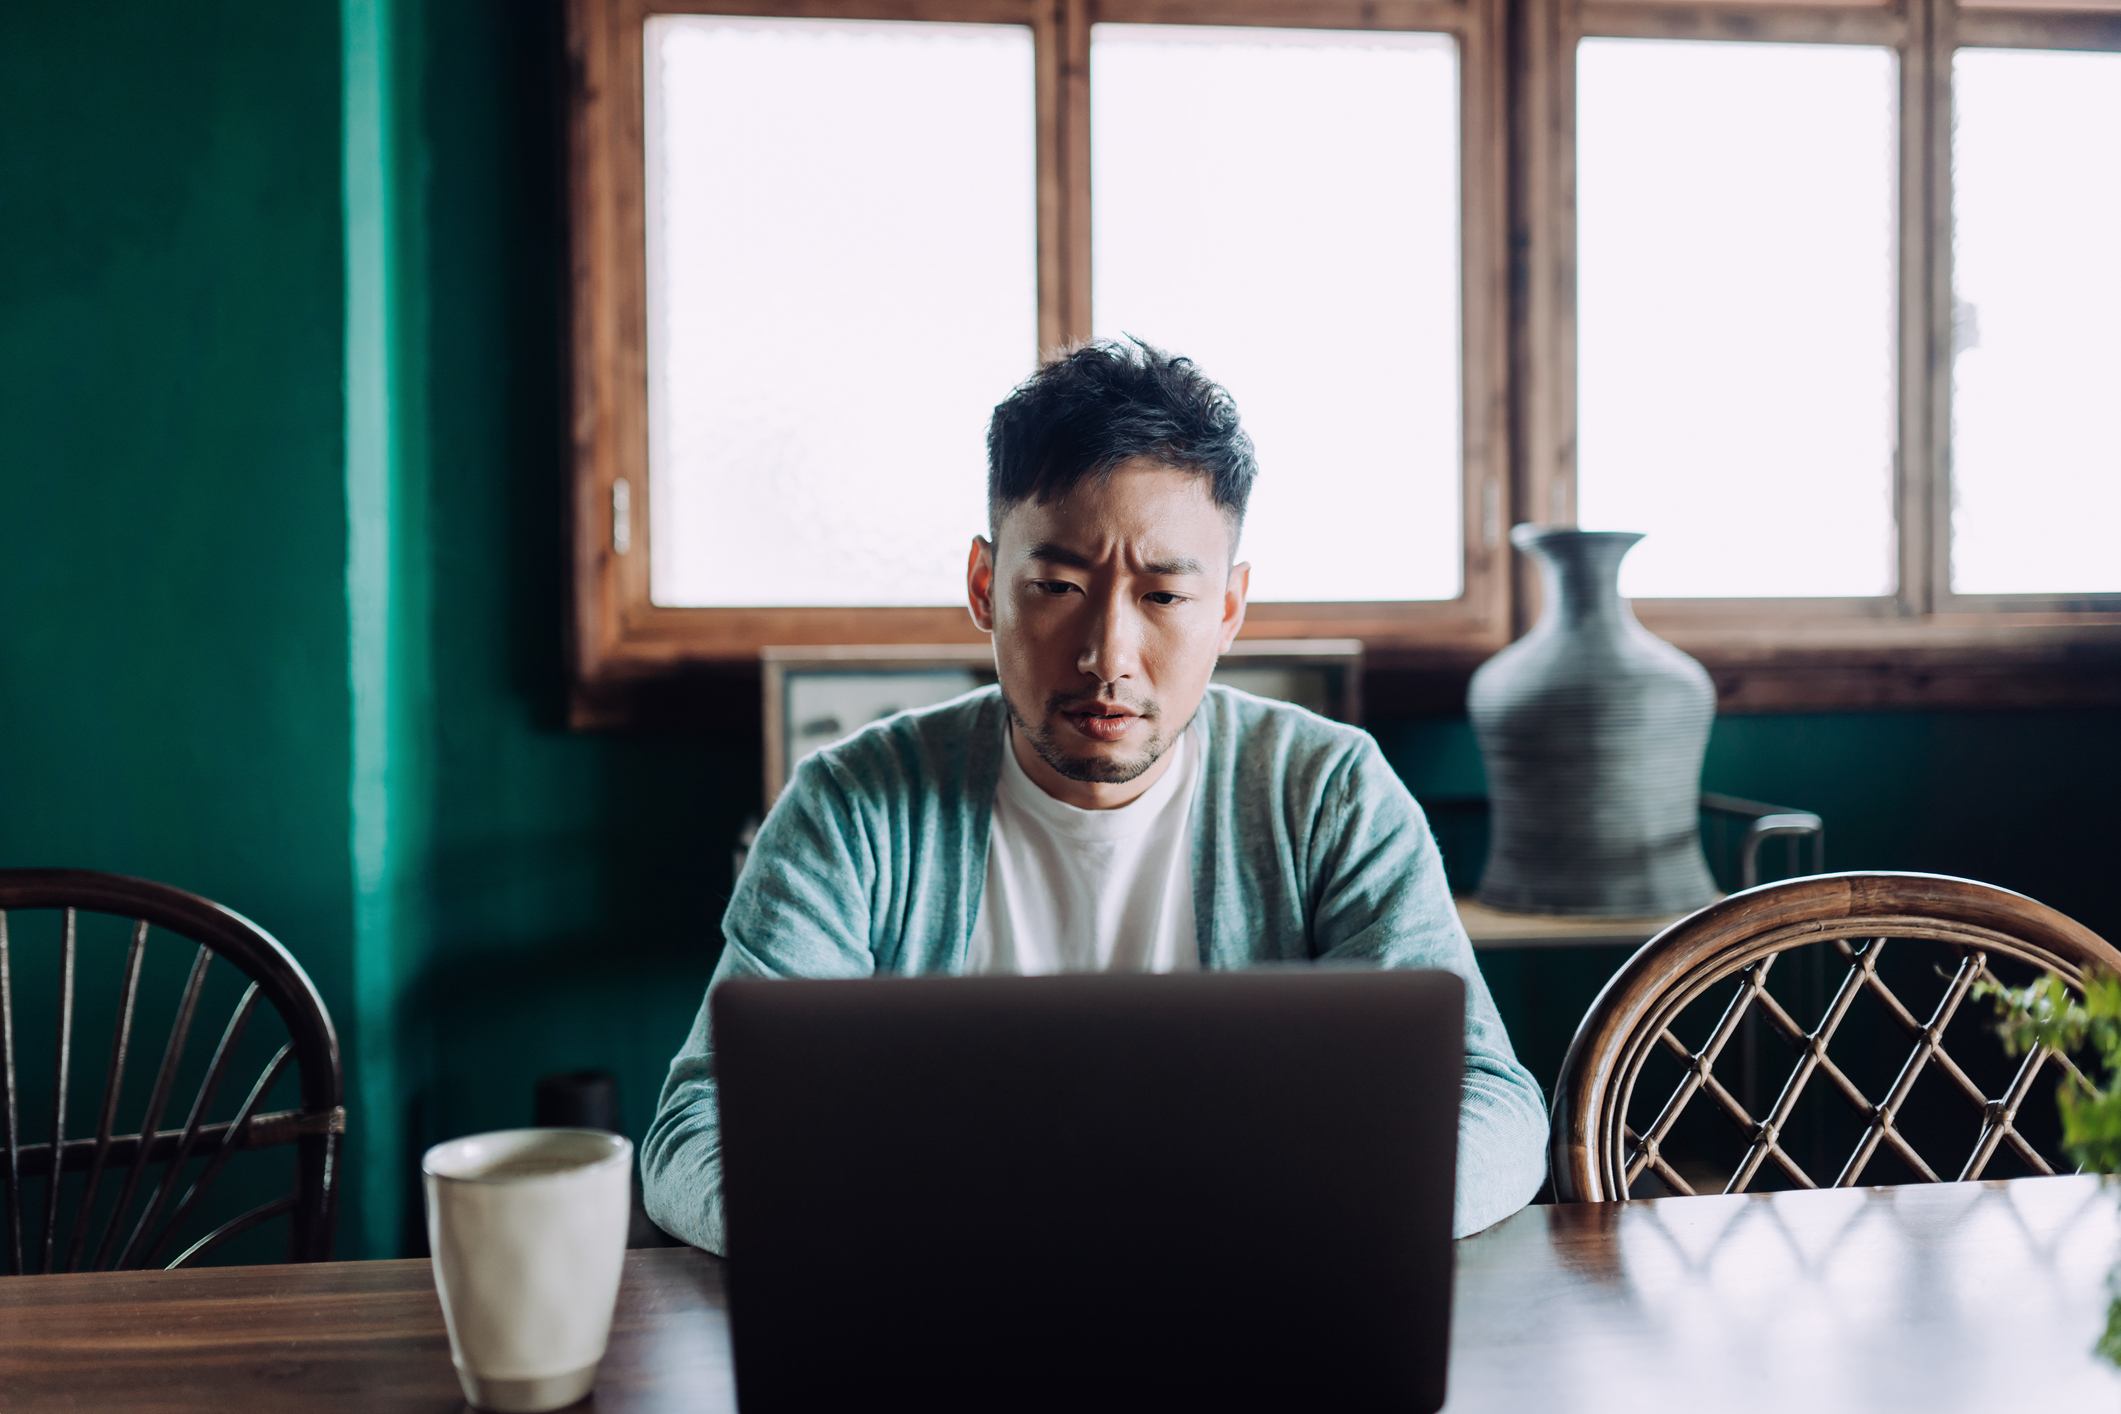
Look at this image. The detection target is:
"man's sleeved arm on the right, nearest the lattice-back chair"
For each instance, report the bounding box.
[1311,738,1546,1236]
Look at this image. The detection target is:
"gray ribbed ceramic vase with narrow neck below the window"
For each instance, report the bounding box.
[1468,526,1718,918]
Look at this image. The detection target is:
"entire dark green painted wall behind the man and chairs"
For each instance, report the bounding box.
[0,0,2121,1255]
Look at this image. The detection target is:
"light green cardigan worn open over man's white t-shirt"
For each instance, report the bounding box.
[641,687,1546,1251]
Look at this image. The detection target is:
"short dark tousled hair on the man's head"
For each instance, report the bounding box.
[986,335,1258,543]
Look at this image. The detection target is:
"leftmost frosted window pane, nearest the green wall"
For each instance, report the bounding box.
[647,15,1037,606]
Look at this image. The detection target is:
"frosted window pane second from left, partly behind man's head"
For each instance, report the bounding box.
[1090,25,1461,600]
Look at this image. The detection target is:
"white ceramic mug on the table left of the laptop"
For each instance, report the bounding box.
[420,1130,634,1414]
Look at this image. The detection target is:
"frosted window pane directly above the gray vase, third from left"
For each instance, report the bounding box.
[1576,40,1898,598]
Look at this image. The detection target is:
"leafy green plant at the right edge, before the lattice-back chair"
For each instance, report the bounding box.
[1975,971,2121,1365]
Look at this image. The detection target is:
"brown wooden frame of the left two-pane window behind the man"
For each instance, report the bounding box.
[568,0,1510,703]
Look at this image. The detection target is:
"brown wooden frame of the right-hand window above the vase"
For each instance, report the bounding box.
[1512,0,2121,708]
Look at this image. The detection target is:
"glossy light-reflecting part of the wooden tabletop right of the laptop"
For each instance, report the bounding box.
[1449,1177,2121,1414]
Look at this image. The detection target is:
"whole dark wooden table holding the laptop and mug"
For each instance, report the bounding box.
[0,1177,2121,1414]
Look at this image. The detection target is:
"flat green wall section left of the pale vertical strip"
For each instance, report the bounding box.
[0,2,365,1255]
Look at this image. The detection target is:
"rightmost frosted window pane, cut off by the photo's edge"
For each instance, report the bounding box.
[1951,49,2121,594]
